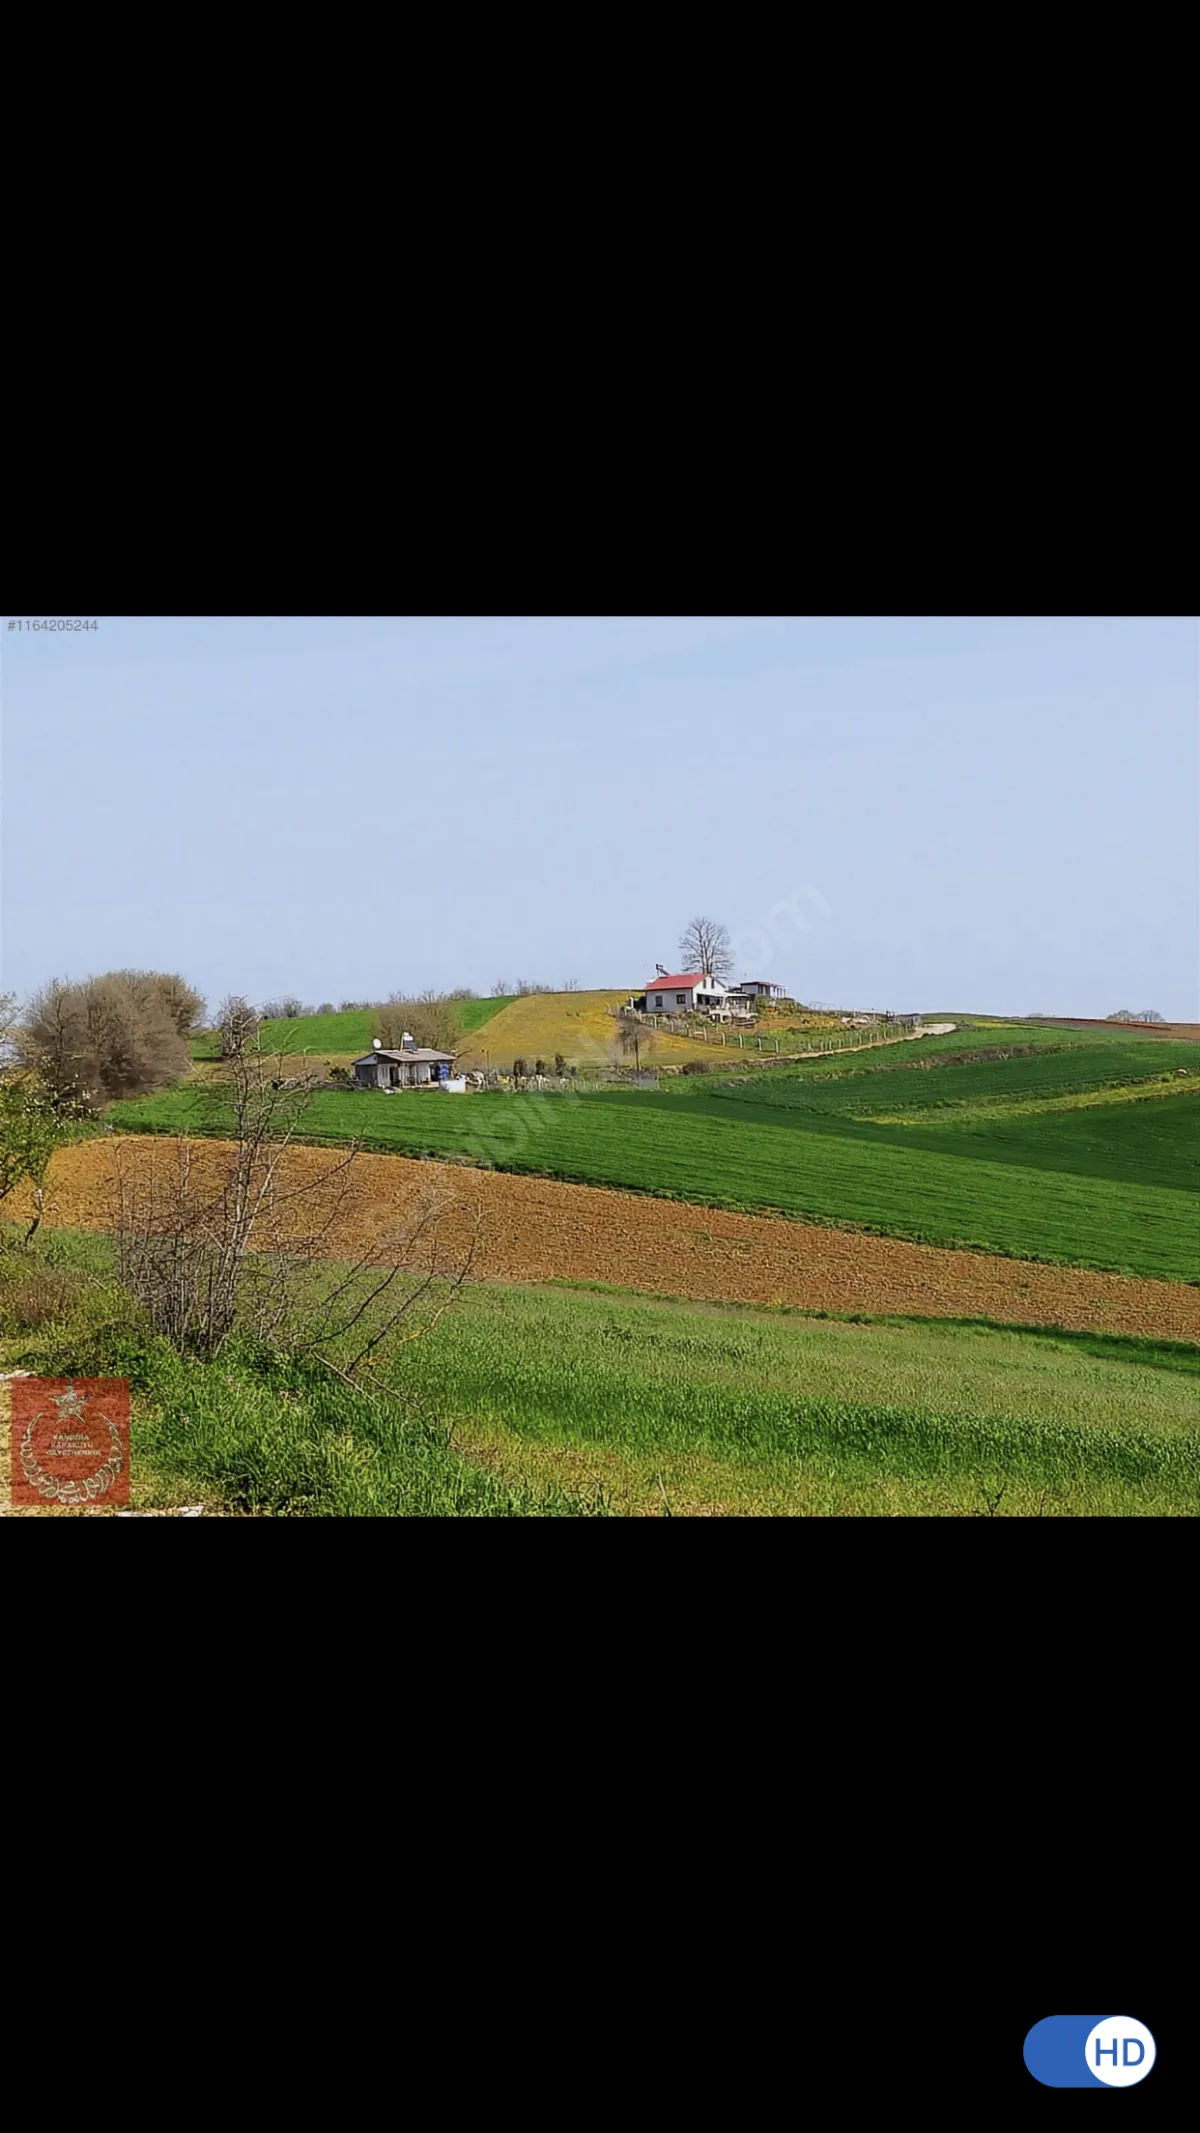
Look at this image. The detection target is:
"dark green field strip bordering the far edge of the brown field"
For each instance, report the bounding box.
[113,1062,1200,1280]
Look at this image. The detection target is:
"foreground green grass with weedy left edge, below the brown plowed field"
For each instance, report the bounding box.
[0,1231,1200,1517]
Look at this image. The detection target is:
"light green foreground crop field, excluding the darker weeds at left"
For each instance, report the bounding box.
[401,1290,1200,1514]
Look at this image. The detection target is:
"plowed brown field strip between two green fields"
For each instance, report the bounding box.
[16,1135,1200,1342]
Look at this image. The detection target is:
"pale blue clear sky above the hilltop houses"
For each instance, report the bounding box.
[0,616,1200,1020]
